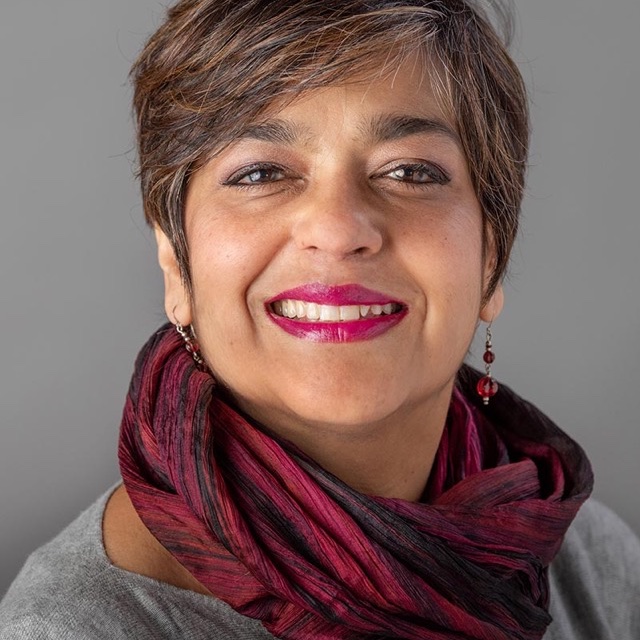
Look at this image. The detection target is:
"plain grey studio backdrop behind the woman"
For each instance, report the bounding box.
[0,0,640,593]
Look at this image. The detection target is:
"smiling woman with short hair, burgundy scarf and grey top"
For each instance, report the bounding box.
[0,0,640,639]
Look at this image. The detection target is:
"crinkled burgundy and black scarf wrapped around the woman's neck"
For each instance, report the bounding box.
[119,325,592,640]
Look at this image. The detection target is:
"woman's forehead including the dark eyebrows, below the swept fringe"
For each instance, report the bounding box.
[192,47,463,172]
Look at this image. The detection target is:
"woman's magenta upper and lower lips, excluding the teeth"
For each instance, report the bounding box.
[265,283,408,343]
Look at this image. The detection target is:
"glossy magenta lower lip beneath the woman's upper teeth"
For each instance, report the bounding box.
[269,309,407,342]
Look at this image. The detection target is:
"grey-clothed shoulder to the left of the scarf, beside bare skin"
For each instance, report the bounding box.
[0,492,272,640]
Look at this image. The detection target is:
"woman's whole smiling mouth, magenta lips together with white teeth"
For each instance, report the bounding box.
[265,283,408,342]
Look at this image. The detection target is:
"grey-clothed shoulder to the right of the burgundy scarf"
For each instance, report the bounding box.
[545,500,640,640]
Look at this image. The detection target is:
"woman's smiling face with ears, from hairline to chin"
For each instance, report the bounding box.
[157,53,502,444]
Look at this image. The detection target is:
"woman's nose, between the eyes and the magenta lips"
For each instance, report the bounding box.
[293,179,384,260]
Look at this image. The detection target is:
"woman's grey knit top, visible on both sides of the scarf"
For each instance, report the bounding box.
[0,492,640,640]
